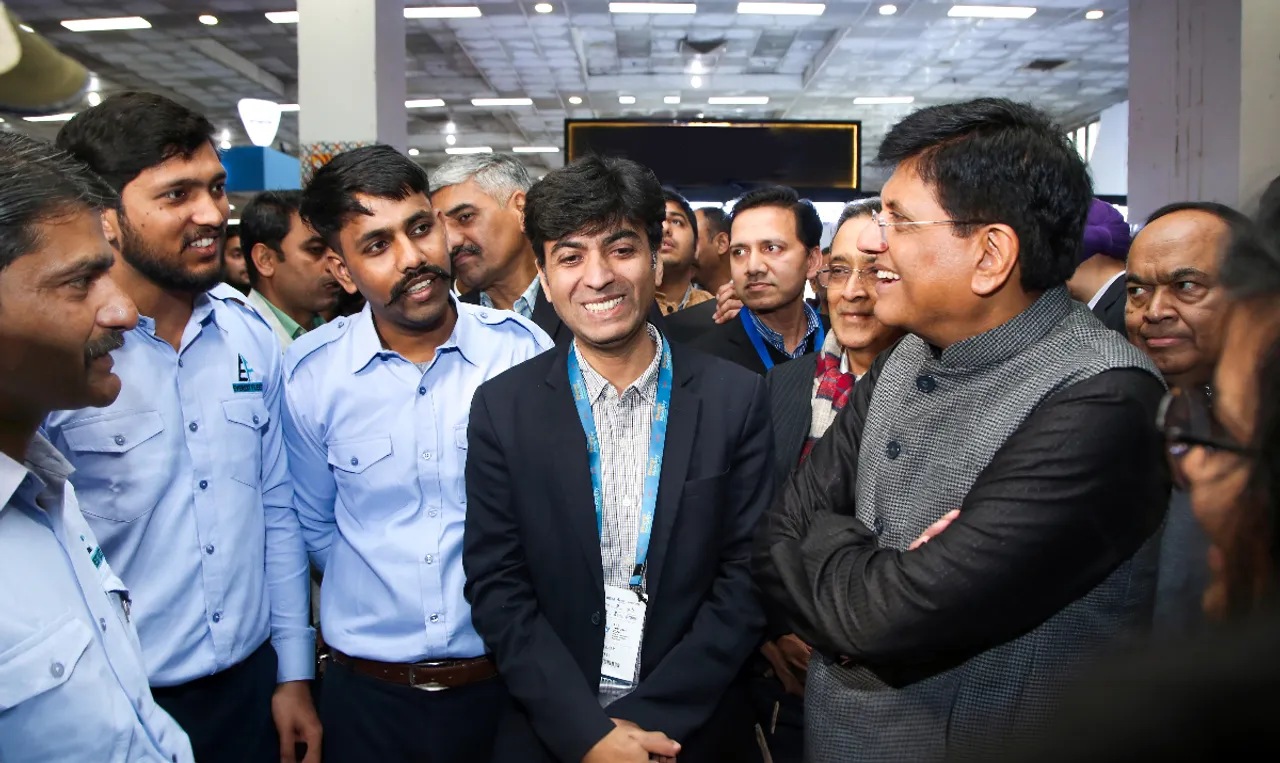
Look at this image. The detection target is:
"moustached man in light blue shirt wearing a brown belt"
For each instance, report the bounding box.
[284,146,552,763]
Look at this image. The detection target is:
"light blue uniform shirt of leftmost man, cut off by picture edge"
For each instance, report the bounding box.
[0,435,192,763]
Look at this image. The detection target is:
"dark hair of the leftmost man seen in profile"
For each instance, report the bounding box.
[0,132,115,270]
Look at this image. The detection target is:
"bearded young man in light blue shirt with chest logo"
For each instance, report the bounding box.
[45,93,320,763]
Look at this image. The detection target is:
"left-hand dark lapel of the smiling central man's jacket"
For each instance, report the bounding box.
[545,342,601,597]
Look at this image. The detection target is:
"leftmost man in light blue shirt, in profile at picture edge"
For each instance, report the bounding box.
[0,133,192,763]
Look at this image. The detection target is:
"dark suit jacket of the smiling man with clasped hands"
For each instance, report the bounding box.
[463,344,773,763]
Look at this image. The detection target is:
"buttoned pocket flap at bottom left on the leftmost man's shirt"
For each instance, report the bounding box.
[0,613,93,713]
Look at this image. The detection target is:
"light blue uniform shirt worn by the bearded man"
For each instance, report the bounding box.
[45,284,315,686]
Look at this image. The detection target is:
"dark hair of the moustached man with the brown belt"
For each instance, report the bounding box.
[302,143,431,255]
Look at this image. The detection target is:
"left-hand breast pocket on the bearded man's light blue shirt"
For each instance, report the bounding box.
[61,411,170,522]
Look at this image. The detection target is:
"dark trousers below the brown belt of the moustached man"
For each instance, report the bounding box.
[320,661,511,763]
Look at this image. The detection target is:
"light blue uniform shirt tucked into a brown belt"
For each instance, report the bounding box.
[284,302,552,663]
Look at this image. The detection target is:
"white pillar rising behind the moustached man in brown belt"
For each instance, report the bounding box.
[297,0,408,182]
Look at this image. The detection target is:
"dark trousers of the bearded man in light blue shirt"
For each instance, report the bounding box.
[151,641,280,763]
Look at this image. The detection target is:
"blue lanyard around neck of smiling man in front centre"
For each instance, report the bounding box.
[568,338,672,594]
